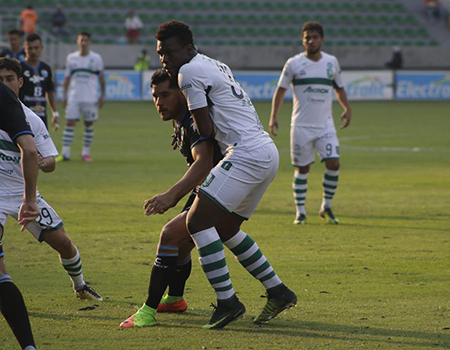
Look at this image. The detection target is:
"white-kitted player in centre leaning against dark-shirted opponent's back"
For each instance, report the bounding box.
[156,21,297,329]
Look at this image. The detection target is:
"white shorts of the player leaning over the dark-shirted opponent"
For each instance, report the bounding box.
[200,143,279,219]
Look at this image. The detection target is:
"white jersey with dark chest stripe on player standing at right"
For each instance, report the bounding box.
[278,52,343,128]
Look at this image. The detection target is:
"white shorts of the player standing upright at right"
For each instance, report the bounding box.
[291,126,339,167]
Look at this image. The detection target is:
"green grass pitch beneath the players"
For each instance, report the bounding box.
[0,102,450,350]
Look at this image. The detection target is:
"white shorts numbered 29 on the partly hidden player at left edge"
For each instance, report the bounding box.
[0,194,63,251]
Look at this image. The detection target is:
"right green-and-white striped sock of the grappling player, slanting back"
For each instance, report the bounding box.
[224,230,281,289]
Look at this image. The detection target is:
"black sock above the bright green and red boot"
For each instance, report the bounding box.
[145,256,177,309]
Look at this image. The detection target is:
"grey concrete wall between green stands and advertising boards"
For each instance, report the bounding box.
[49,44,450,70]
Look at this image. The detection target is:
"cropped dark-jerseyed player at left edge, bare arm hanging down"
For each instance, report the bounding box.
[0,82,39,350]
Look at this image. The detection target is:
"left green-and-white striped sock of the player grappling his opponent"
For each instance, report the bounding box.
[192,227,235,300]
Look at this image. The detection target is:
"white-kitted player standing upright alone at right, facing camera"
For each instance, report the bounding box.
[269,22,352,225]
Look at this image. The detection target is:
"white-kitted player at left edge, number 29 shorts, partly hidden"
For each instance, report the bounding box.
[0,58,103,301]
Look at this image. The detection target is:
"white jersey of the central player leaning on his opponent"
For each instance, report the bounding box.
[178,54,272,153]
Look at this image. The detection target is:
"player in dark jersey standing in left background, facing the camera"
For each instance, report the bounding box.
[19,34,59,130]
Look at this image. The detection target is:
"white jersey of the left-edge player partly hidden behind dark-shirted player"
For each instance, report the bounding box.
[0,103,58,195]
